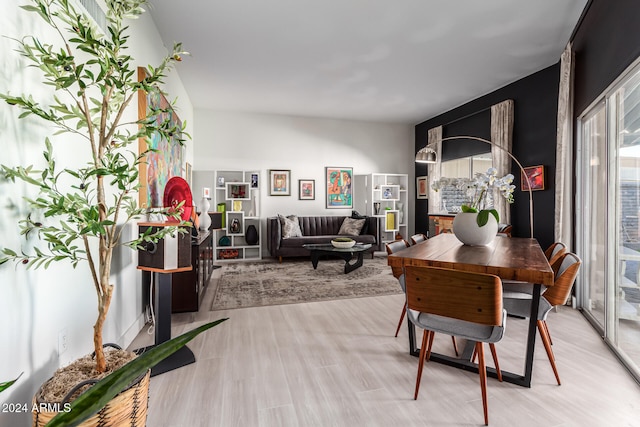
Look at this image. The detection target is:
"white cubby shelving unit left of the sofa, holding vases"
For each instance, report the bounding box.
[211,170,263,261]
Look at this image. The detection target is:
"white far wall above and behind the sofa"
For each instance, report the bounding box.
[193,109,415,247]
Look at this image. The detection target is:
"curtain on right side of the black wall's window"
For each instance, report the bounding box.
[491,99,513,224]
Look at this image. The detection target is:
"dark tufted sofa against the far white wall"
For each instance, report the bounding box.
[267,216,380,262]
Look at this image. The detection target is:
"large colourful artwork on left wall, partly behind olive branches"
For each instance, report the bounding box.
[138,67,183,208]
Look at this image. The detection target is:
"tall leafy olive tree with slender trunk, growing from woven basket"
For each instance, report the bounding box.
[0,0,226,426]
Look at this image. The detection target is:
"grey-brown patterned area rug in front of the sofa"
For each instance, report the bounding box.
[211,257,402,311]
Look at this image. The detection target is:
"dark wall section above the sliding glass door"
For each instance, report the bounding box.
[572,0,640,118]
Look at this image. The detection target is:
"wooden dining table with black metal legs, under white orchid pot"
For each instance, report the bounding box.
[387,233,554,387]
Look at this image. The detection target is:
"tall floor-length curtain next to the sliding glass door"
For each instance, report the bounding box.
[553,43,573,250]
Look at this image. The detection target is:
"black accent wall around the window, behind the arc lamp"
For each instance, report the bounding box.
[415,63,560,251]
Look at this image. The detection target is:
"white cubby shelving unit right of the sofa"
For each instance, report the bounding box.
[354,173,409,251]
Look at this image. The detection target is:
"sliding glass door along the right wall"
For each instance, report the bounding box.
[576,57,640,378]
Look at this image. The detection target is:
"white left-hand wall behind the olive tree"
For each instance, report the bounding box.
[0,1,193,426]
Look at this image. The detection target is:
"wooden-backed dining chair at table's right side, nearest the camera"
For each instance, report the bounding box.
[503,252,582,385]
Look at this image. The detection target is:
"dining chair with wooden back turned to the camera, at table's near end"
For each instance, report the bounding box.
[405,266,507,425]
